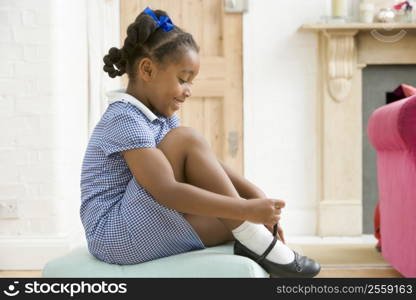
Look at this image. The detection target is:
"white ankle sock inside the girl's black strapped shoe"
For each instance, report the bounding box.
[231,221,295,264]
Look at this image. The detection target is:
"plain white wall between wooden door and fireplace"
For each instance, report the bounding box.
[243,0,327,236]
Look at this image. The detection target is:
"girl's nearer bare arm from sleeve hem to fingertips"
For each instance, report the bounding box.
[121,148,283,224]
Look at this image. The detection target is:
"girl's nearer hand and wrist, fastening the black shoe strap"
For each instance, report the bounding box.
[244,198,285,226]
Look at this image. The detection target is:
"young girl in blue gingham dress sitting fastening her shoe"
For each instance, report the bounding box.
[80,8,320,277]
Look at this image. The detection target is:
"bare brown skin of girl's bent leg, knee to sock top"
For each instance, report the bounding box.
[158,127,243,246]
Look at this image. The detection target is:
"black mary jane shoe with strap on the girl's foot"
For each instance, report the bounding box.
[234,225,321,278]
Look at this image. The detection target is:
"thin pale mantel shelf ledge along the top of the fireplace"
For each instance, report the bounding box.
[301,23,416,31]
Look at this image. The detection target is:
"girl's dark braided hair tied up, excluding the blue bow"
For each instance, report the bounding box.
[103,10,199,79]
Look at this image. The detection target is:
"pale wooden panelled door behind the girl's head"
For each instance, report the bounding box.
[120,0,243,174]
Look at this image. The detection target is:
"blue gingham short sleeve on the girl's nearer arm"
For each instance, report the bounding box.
[100,112,156,156]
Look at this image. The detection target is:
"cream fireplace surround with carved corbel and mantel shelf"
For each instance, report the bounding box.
[301,23,416,236]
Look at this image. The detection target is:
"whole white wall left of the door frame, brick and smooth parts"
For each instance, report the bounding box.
[0,0,88,258]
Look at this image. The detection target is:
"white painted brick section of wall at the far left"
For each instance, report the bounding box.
[0,0,56,236]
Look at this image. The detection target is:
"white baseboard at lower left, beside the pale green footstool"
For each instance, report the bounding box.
[0,235,71,270]
